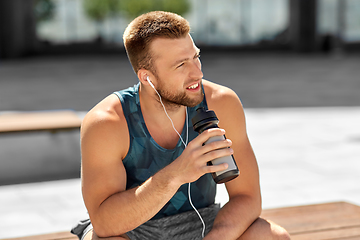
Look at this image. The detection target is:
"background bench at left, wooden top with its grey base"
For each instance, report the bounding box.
[0,110,82,185]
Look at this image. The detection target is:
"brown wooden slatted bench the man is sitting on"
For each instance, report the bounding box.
[3,202,360,240]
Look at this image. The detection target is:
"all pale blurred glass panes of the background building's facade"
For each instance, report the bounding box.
[37,0,360,46]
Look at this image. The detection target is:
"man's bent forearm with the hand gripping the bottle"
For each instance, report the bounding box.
[88,129,232,237]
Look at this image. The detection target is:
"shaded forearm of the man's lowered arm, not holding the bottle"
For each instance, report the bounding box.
[204,195,261,240]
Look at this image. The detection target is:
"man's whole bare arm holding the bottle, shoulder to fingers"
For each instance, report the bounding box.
[81,96,230,237]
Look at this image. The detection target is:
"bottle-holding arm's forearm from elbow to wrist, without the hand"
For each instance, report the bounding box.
[90,166,180,237]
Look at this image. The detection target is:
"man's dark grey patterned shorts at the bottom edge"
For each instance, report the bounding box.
[71,204,220,240]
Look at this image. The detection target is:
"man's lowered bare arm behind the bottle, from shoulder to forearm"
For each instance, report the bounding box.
[204,80,261,239]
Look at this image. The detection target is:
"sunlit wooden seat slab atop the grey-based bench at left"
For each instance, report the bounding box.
[0,110,81,133]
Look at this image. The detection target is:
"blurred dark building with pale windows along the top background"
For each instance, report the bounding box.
[0,0,360,58]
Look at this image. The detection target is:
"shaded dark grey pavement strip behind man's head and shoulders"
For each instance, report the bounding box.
[0,50,360,111]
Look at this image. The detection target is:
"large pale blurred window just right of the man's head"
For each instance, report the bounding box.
[189,0,288,45]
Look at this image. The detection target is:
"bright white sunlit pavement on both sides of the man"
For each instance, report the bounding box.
[0,107,360,239]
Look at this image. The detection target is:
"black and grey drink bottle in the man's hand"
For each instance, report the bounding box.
[191,107,239,184]
